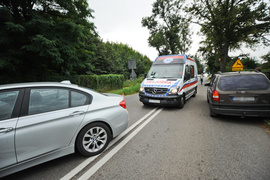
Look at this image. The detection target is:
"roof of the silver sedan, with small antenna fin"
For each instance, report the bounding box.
[0,81,78,90]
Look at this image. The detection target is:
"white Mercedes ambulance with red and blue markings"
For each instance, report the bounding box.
[139,55,198,109]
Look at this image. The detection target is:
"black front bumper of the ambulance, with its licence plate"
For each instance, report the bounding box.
[139,92,181,106]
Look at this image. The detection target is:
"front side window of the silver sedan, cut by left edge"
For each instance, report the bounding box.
[0,91,19,120]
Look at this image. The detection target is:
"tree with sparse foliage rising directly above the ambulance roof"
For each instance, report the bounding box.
[142,0,191,55]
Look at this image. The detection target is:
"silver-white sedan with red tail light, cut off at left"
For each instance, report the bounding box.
[0,82,129,178]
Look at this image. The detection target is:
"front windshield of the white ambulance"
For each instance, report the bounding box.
[147,64,183,78]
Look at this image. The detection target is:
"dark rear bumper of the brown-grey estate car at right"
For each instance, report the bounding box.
[209,103,270,117]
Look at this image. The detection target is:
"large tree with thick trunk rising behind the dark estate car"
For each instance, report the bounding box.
[188,0,270,72]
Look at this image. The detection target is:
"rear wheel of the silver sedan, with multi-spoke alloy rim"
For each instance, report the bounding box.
[75,122,112,157]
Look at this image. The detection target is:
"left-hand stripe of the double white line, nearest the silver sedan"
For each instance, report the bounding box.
[60,108,162,180]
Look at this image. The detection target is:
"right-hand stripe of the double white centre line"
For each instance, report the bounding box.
[78,108,162,180]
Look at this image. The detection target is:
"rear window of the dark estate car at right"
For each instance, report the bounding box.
[218,75,270,91]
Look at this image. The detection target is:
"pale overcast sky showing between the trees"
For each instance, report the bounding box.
[88,0,270,61]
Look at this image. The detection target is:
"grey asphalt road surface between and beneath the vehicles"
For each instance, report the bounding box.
[4,80,270,180]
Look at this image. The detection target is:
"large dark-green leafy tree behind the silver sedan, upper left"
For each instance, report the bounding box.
[0,0,99,81]
